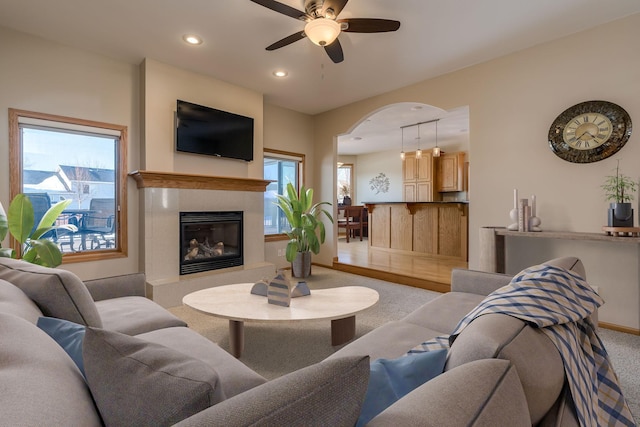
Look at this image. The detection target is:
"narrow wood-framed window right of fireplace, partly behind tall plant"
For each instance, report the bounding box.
[264,149,304,235]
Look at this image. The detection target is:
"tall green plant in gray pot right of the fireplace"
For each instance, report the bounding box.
[275,183,333,277]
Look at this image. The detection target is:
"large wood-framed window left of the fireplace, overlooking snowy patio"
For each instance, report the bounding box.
[9,109,127,263]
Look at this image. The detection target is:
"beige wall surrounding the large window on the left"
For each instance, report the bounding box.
[0,28,140,279]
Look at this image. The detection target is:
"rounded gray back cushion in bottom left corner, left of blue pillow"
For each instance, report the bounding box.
[0,313,102,426]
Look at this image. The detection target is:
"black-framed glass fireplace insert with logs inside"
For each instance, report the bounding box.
[180,211,244,275]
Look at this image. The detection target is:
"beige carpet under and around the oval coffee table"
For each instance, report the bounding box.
[170,266,640,420]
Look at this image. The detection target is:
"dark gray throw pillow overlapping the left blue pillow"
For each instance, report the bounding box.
[82,327,225,426]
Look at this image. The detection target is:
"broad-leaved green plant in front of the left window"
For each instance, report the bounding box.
[0,194,77,267]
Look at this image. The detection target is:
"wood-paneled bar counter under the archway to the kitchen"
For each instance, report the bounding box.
[364,201,469,261]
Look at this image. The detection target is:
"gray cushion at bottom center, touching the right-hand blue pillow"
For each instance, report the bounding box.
[176,356,369,427]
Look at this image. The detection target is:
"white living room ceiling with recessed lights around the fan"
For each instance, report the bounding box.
[0,0,640,155]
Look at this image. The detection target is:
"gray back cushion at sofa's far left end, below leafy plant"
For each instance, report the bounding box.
[0,257,102,328]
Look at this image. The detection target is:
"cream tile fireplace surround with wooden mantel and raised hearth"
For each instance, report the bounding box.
[129,171,275,307]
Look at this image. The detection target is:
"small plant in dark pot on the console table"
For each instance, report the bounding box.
[601,161,638,227]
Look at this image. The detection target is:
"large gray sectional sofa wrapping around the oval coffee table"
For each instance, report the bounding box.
[0,258,584,426]
